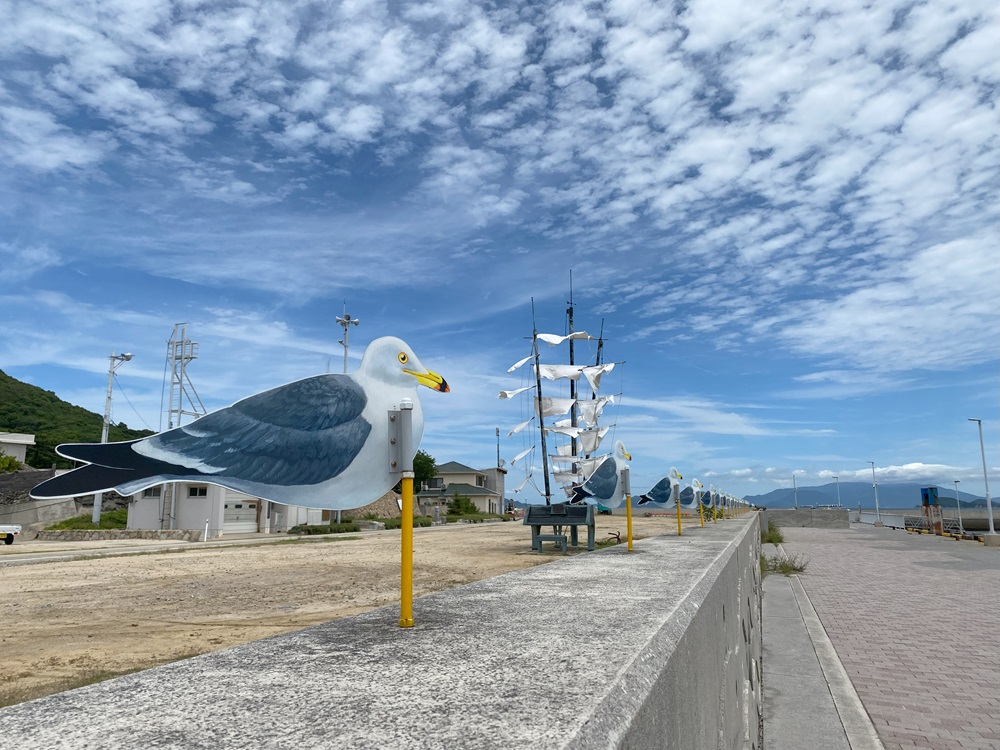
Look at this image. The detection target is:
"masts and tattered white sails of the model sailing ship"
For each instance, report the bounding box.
[500,294,631,508]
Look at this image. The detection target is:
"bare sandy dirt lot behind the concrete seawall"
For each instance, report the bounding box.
[0,514,677,706]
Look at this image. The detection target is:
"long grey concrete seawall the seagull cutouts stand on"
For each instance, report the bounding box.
[0,514,762,750]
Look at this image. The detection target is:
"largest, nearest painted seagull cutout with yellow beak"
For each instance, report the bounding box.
[31,336,450,510]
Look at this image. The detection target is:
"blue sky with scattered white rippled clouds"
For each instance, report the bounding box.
[0,0,1000,506]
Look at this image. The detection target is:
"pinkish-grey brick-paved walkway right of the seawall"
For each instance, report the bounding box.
[782,527,1000,750]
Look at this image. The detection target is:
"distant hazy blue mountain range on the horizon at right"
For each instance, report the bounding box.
[744,482,986,508]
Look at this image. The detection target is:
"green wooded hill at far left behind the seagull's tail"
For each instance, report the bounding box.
[0,370,153,469]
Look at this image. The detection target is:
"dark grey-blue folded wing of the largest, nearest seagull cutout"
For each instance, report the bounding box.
[142,375,371,486]
